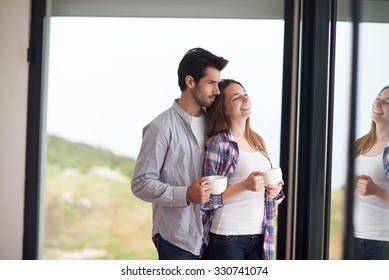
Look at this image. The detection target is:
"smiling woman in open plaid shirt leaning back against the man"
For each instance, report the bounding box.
[203,79,284,260]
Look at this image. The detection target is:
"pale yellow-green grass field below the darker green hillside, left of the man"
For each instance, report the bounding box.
[43,168,156,260]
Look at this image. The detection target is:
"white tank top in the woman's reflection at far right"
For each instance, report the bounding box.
[354,153,389,241]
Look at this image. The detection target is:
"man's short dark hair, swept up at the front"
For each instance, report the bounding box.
[177,48,228,91]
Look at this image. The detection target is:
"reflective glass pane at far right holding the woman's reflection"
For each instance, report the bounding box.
[353,19,389,259]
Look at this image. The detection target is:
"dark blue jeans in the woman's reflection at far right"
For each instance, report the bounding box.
[354,238,389,260]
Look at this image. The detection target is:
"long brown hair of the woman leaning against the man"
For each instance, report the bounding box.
[207,79,268,156]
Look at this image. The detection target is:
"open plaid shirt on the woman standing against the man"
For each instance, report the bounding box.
[202,132,285,260]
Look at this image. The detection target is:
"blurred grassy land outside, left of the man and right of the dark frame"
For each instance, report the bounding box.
[43,135,343,260]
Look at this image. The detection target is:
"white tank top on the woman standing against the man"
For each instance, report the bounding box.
[211,150,271,235]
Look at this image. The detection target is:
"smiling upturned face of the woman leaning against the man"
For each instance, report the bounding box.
[223,84,251,120]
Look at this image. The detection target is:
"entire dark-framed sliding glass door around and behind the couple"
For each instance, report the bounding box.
[23,0,389,259]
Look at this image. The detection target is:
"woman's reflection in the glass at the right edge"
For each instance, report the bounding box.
[354,86,389,259]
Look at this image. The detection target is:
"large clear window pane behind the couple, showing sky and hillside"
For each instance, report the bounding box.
[43,17,284,259]
